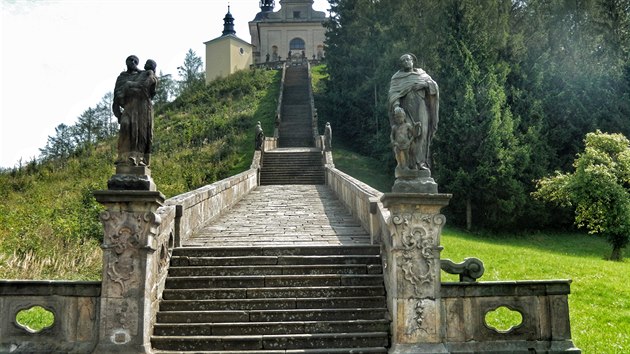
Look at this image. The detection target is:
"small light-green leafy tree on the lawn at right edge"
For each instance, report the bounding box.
[534,130,630,260]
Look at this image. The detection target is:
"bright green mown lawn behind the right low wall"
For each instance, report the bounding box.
[442,228,630,354]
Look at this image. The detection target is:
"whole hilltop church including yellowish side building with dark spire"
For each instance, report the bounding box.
[204,0,326,82]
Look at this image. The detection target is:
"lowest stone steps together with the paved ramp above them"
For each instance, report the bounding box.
[151,185,389,354]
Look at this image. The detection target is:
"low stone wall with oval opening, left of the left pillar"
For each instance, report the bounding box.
[0,280,101,353]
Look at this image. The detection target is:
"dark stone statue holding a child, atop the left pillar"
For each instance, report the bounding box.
[112,55,158,166]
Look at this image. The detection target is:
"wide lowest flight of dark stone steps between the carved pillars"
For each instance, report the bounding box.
[151,245,389,354]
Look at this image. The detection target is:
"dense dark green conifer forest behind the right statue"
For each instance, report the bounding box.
[318,0,630,229]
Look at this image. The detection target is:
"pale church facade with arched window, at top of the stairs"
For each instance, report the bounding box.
[249,0,326,63]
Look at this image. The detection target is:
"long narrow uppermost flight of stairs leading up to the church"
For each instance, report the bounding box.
[278,65,314,147]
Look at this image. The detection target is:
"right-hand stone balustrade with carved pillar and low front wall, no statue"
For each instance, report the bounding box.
[325,162,580,354]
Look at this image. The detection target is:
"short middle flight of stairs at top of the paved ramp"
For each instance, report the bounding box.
[260,148,326,185]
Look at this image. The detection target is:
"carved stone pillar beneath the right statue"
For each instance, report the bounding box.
[381,193,451,354]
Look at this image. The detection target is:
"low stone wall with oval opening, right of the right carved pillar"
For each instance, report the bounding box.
[441,280,580,353]
